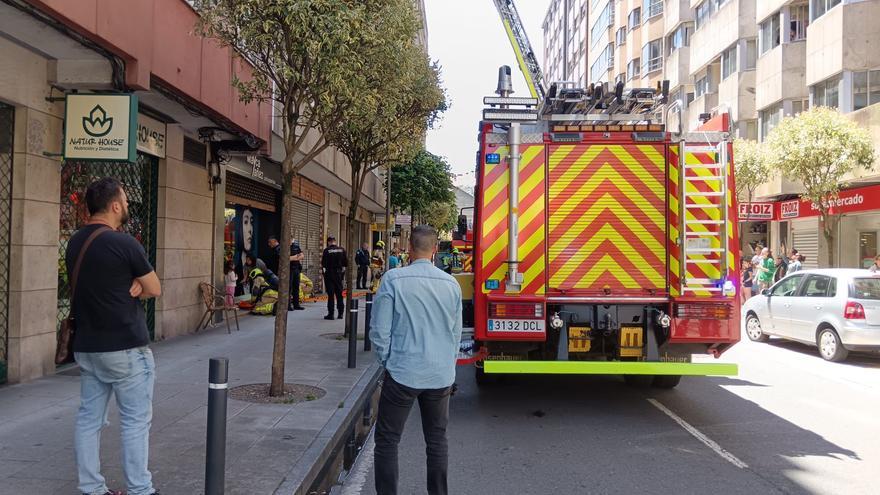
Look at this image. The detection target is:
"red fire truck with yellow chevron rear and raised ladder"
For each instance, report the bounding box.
[458,0,740,388]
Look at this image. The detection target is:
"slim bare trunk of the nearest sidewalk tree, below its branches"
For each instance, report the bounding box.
[269,171,296,397]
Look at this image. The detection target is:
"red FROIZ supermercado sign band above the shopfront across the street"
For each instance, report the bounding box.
[739,185,880,221]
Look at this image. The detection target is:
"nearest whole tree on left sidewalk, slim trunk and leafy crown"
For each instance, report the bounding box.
[194,0,380,396]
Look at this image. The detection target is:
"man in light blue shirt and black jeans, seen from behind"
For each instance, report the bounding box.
[370,225,462,495]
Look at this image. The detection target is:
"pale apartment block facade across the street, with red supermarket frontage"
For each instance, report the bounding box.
[544,0,880,267]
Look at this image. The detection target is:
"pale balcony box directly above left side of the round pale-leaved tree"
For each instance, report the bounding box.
[755,41,809,108]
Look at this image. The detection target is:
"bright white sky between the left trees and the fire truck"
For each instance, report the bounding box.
[425,0,550,190]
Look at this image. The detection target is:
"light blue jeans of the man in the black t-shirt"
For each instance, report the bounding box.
[75,347,156,495]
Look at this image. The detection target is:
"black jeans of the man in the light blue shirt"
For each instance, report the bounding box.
[375,372,452,495]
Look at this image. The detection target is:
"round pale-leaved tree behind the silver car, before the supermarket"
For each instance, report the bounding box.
[765,107,874,266]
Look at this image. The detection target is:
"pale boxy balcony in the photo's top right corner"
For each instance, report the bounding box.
[806,2,880,86]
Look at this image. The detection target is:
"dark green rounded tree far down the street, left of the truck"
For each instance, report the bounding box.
[391,150,455,221]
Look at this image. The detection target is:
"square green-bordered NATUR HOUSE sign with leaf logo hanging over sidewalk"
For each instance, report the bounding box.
[63,94,138,162]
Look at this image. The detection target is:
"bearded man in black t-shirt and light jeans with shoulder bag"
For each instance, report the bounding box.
[65,177,162,495]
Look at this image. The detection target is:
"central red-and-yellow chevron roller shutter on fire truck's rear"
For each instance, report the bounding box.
[547,144,668,295]
